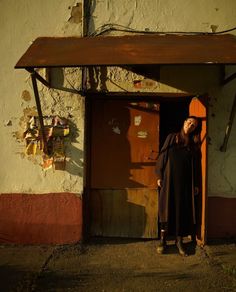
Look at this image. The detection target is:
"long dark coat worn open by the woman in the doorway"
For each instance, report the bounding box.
[156,133,201,236]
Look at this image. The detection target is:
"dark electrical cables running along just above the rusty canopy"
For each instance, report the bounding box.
[89,23,236,37]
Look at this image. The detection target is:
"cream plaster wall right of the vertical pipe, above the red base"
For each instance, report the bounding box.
[89,0,236,198]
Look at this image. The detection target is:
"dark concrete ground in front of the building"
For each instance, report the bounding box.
[0,239,236,292]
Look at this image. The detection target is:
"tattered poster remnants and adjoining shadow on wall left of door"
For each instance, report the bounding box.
[23,115,83,177]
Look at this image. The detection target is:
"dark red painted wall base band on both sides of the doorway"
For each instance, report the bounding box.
[0,193,236,244]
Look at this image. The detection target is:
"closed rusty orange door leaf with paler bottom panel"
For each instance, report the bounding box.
[89,99,159,238]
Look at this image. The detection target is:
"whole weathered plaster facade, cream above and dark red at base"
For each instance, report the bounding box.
[0,0,236,243]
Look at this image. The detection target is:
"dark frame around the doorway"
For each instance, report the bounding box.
[82,92,208,245]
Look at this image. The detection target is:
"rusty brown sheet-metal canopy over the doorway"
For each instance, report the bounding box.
[15,34,236,69]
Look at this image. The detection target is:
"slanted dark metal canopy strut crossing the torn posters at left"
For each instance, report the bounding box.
[31,72,48,154]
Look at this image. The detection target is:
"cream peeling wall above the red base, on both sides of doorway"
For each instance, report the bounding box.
[0,0,236,197]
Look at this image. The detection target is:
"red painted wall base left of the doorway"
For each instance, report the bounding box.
[0,193,82,244]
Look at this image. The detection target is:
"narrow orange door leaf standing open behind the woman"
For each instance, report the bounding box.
[189,96,207,245]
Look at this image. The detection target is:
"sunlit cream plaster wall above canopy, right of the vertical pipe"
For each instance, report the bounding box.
[90,0,236,32]
